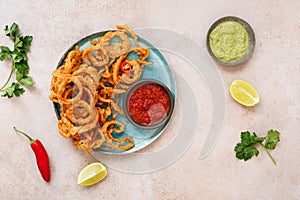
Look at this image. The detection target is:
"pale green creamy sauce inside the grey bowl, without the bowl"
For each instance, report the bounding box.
[209,21,249,62]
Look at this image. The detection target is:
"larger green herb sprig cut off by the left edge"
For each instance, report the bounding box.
[0,23,35,98]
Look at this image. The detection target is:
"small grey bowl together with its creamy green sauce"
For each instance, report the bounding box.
[206,16,255,66]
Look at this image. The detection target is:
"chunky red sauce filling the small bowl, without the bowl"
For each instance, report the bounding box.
[128,83,170,125]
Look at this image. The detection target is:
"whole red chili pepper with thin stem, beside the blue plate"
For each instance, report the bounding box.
[14,127,50,182]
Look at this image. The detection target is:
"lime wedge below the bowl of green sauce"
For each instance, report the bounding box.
[230,80,259,106]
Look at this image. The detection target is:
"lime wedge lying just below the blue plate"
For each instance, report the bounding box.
[77,162,107,186]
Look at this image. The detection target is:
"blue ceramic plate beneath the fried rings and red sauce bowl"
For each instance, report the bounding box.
[54,31,176,155]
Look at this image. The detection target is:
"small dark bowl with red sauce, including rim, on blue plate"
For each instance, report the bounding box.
[124,79,175,129]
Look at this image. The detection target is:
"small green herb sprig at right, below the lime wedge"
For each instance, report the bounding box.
[234,129,280,165]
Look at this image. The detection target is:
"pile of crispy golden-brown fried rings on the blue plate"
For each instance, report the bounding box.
[50,26,152,153]
